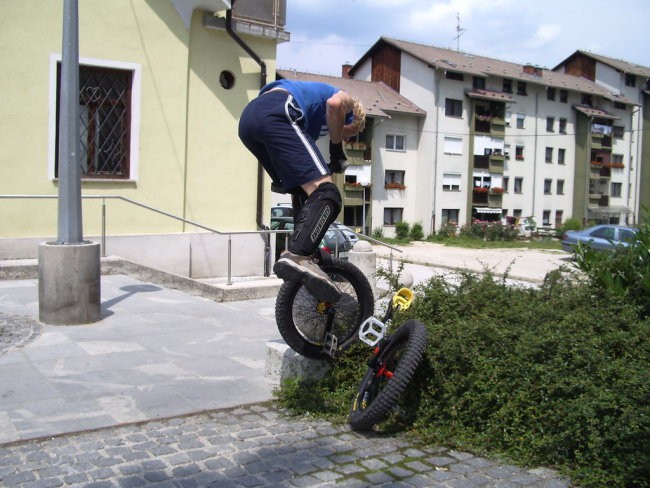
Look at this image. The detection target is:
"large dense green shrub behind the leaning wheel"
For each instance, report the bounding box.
[280,270,650,487]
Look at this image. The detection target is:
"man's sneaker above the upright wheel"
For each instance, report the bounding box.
[273,251,341,302]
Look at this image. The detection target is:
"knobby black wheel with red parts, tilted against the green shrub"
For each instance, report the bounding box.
[348,320,427,430]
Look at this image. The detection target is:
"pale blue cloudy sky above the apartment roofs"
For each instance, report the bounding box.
[277,0,650,76]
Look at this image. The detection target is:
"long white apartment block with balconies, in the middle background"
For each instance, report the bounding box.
[349,37,648,233]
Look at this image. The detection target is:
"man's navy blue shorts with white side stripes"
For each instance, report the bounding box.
[239,90,330,193]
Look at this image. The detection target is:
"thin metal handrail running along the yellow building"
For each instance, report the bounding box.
[0,195,402,285]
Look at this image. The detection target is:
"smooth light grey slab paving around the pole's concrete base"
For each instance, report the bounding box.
[0,275,280,443]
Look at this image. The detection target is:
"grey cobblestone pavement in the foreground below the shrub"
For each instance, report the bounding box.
[0,404,570,488]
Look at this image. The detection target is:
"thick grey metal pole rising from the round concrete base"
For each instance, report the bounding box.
[58,0,83,244]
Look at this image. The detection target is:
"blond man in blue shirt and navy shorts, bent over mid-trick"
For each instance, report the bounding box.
[239,80,365,301]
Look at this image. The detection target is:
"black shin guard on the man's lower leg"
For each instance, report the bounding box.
[289,182,341,256]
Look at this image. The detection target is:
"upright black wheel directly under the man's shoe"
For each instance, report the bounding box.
[275,258,374,359]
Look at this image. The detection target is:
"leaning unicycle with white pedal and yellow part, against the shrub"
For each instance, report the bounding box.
[348,288,427,430]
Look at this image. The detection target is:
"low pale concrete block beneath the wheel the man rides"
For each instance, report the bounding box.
[264,340,331,383]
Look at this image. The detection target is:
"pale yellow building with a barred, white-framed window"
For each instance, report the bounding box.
[0,0,289,276]
